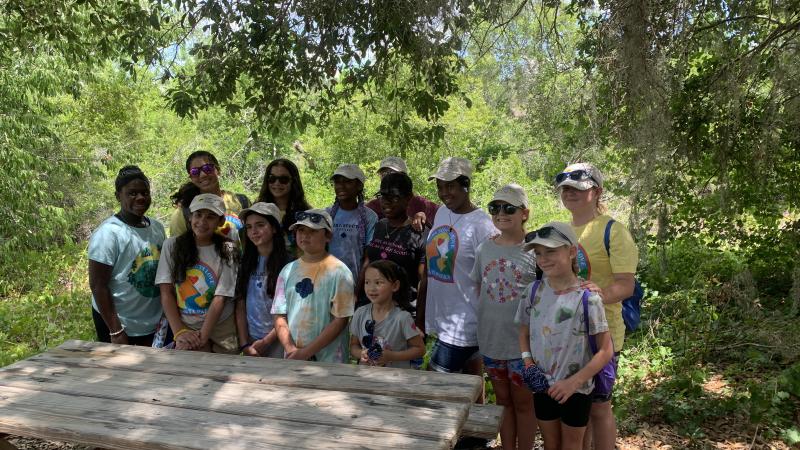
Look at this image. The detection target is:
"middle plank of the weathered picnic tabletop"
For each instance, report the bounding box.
[0,361,469,442]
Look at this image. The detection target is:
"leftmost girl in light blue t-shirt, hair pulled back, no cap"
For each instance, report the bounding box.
[89,166,165,346]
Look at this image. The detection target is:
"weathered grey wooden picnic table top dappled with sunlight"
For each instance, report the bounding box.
[0,341,488,449]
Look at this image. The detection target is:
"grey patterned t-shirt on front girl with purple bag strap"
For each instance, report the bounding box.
[514,279,608,395]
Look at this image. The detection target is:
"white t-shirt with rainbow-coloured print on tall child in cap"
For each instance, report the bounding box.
[425,206,498,347]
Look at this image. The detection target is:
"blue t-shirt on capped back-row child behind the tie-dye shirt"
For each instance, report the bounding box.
[328,207,378,280]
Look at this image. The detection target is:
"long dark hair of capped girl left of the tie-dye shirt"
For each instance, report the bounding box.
[236,212,289,298]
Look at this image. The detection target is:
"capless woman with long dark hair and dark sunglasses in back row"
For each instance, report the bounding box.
[256,158,311,256]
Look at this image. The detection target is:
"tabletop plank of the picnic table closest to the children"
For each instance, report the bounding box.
[37,341,483,402]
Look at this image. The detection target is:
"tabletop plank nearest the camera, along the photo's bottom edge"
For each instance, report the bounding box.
[0,387,449,450]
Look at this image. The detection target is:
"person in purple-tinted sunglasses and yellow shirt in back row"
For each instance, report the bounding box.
[169,150,250,241]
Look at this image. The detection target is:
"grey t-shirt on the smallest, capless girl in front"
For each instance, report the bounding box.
[350,303,422,369]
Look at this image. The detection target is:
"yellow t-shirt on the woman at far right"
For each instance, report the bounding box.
[572,215,639,352]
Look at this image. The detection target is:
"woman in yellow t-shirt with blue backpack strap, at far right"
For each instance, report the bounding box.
[556,163,639,450]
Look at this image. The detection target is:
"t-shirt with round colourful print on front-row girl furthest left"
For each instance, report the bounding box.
[156,238,237,329]
